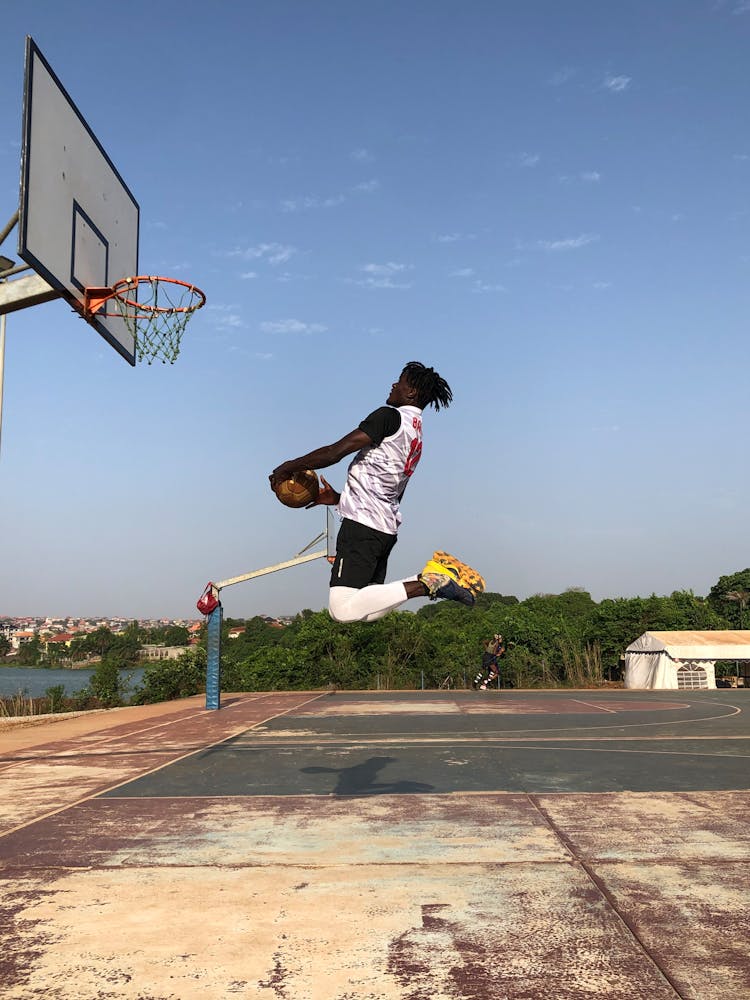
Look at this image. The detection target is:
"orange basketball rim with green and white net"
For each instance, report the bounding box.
[84,275,206,365]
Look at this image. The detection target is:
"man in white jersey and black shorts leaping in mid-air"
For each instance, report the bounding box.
[268,361,484,622]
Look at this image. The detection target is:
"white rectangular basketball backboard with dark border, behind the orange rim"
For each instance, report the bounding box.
[18,37,140,365]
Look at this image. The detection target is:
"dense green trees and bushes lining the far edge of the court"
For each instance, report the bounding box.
[2,568,750,703]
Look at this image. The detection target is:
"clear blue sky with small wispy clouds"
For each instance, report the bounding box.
[0,0,750,617]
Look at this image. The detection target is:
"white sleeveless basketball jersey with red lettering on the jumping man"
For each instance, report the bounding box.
[338,406,422,535]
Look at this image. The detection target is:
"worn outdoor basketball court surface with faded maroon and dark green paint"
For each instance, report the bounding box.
[0,690,750,1000]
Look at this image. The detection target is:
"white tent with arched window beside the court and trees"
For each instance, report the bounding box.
[625,629,750,690]
